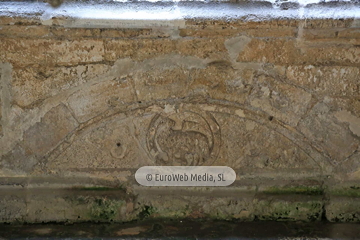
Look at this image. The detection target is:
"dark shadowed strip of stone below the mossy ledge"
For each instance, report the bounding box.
[0,219,360,240]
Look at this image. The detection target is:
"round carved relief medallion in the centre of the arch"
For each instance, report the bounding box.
[147,111,220,166]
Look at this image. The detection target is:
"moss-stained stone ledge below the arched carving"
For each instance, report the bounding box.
[0,178,360,223]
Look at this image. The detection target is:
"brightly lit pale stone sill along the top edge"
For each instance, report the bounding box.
[0,1,360,28]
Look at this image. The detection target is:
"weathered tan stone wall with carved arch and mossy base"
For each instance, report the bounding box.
[0,14,360,222]
